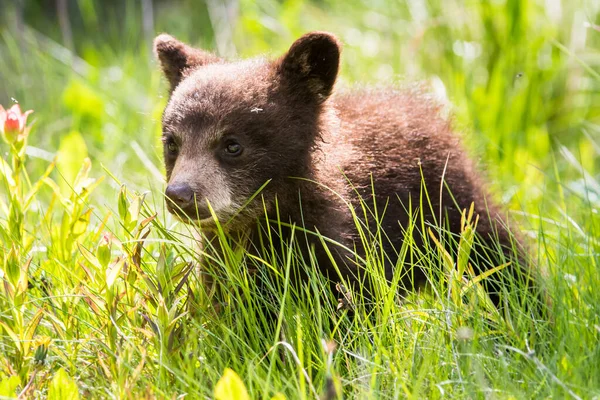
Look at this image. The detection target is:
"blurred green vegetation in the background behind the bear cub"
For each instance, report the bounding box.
[0,0,600,210]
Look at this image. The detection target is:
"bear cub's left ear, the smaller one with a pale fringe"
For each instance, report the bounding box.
[154,33,222,91]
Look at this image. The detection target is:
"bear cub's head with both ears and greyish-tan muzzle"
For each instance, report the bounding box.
[154,32,340,226]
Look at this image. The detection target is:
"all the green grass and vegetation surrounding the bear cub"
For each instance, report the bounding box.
[0,0,600,399]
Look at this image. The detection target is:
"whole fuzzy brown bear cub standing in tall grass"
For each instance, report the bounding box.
[154,32,527,303]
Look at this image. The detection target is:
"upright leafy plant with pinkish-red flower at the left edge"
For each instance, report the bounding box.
[0,104,46,382]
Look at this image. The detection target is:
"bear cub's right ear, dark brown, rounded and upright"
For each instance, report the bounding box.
[278,32,341,102]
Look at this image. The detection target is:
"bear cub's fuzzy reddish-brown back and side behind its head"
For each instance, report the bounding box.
[318,89,510,284]
